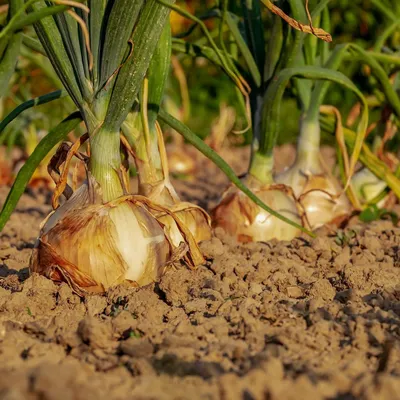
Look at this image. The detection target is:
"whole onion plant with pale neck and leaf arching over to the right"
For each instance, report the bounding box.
[269,41,368,230]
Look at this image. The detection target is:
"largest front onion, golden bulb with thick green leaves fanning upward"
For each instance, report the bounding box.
[23,0,203,295]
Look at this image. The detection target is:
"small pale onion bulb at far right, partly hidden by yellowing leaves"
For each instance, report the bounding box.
[351,168,387,207]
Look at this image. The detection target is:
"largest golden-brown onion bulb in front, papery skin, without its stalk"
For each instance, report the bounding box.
[30,192,172,295]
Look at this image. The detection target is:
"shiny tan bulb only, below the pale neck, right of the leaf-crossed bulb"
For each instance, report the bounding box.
[275,164,351,230]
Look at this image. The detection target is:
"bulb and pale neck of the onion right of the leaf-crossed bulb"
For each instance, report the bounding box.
[275,121,350,230]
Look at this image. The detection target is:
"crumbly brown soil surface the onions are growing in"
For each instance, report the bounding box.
[0,145,400,400]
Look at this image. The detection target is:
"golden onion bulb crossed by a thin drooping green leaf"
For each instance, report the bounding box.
[212,179,301,242]
